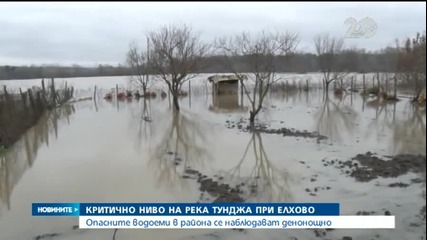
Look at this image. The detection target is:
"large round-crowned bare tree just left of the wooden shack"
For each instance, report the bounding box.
[148,25,209,110]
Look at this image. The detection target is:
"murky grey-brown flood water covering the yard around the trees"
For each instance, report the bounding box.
[0,74,426,240]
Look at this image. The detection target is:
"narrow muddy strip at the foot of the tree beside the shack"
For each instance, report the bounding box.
[226,119,327,141]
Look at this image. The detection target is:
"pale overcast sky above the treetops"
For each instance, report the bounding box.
[0,2,426,66]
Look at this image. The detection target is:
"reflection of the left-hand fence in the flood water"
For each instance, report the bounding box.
[0,105,75,213]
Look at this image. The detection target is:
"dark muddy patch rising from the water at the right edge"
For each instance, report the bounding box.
[322,152,426,182]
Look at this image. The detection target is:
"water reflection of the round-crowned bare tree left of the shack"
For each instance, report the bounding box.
[150,110,213,191]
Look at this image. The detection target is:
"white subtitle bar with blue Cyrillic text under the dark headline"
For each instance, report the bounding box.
[79,216,395,229]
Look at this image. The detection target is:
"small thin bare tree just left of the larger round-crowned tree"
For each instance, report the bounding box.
[126,42,149,95]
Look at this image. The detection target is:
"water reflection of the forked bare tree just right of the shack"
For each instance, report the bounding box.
[221,132,292,202]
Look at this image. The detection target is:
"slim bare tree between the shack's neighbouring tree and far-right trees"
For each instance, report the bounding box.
[314,34,348,94]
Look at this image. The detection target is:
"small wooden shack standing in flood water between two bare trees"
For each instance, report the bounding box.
[208,75,247,94]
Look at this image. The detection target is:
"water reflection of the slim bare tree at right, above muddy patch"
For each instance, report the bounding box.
[314,97,358,140]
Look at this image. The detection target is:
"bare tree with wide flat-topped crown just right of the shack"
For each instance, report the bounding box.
[217,32,298,127]
